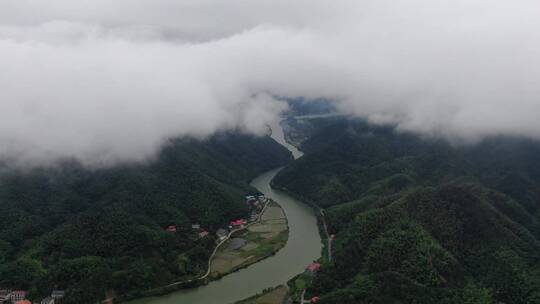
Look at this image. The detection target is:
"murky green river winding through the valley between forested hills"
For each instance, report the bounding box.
[130,123,322,304]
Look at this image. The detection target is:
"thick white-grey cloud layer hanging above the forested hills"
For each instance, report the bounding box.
[0,0,540,164]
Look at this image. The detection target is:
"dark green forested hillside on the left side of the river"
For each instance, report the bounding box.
[0,134,292,304]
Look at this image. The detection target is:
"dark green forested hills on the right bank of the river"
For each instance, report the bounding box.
[274,118,540,304]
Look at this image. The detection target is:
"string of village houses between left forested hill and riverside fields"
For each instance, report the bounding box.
[165,195,268,243]
